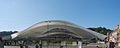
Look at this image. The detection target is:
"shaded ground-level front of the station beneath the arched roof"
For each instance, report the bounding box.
[5,34,82,48]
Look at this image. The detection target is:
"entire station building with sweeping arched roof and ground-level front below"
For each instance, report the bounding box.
[0,20,106,48]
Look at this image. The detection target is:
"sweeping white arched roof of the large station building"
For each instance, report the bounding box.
[12,20,106,40]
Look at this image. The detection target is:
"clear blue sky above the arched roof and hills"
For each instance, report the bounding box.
[0,0,120,31]
